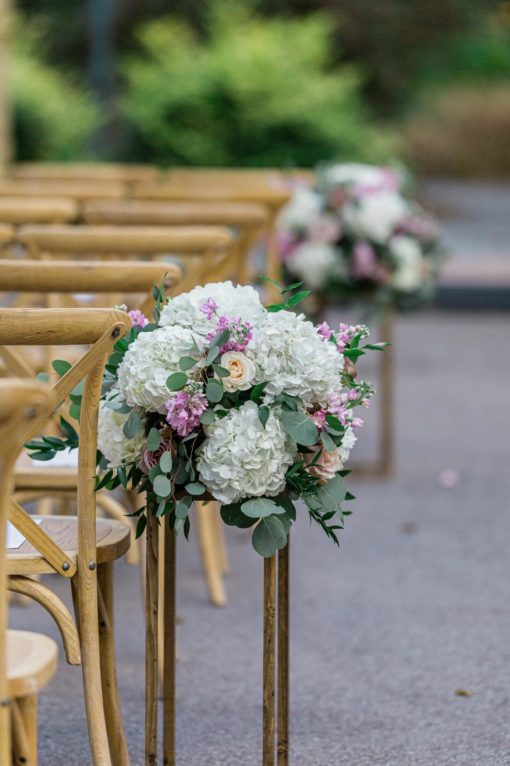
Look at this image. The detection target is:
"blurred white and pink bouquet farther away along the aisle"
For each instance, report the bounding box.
[279,163,443,308]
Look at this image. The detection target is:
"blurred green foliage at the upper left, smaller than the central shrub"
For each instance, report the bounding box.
[9,19,100,160]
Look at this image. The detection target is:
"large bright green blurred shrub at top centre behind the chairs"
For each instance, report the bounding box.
[121,0,390,166]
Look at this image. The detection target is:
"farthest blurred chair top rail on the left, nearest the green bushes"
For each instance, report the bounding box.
[8,162,159,183]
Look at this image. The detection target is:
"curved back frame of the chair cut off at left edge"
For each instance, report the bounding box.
[0,379,55,766]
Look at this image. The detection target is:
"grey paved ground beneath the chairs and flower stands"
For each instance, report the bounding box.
[12,313,510,766]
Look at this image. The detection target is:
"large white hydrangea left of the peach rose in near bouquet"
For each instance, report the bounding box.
[118,325,205,412]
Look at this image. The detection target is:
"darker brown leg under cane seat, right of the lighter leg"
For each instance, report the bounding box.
[97,562,130,766]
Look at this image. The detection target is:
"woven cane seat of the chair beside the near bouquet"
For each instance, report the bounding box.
[7,516,131,575]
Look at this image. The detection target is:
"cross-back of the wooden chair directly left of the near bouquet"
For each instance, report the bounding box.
[0,308,131,577]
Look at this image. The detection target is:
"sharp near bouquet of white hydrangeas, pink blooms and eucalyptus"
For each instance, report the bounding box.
[27,282,385,557]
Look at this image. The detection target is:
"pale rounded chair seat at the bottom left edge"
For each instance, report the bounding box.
[7,630,58,698]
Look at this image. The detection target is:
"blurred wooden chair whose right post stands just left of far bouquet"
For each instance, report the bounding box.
[131,178,291,300]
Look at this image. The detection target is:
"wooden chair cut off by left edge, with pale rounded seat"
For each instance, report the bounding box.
[0,379,58,766]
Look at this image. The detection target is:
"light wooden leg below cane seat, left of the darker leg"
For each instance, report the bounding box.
[71,570,113,766]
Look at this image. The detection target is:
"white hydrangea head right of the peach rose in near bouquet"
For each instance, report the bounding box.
[249,311,343,406]
